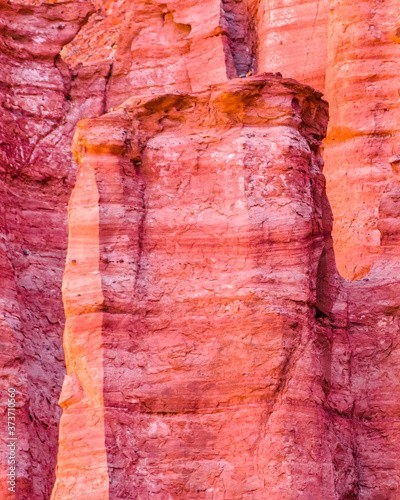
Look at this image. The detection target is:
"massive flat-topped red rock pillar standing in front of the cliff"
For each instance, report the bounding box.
[52,71,372,499]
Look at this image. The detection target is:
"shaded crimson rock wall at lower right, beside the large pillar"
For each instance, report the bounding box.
[345,161,400,500]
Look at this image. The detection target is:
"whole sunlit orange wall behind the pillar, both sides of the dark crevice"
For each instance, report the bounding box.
[64,0,400,280]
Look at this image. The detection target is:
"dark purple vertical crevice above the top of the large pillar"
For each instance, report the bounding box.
[221,0,257,76]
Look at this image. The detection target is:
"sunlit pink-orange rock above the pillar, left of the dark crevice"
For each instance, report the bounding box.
[63,0,237,106]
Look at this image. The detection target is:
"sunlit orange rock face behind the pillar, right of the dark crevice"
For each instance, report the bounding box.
[219,0,400,279]
